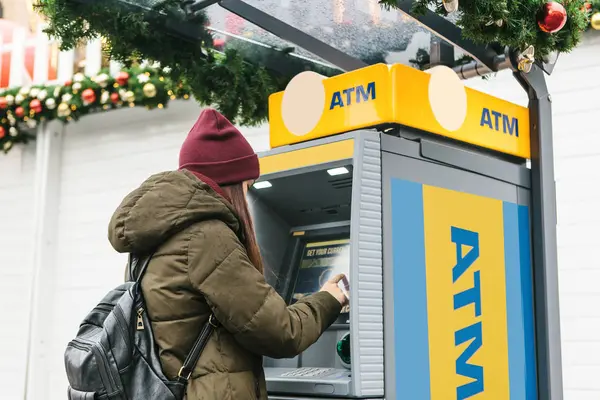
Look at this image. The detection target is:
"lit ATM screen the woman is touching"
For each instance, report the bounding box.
[292,239,350,313]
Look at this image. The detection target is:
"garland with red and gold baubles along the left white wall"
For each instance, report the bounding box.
[0,66,191,153]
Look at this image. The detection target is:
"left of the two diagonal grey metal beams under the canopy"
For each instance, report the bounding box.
[219,0,368,71]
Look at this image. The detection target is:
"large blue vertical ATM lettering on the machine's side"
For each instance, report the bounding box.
[450,226,484,400]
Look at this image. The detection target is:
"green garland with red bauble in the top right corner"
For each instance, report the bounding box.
[379,0,598,60]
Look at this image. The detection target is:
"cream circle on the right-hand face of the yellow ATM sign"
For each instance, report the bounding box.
[427,65,467,132]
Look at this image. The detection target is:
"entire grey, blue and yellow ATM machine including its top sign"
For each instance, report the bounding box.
[250,60,556,400]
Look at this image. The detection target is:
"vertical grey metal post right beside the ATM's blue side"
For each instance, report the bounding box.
[514,65,563,400]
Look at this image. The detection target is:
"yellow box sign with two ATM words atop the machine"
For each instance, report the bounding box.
[269,64,530,158]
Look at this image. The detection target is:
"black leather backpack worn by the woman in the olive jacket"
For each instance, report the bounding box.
[65,256,217,400]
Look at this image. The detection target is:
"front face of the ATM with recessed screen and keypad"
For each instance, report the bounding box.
[250,130,383,399]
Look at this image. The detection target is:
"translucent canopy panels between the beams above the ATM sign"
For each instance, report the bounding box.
[205,0,486,72]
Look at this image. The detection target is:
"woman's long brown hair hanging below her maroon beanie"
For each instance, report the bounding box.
[222,183,264,273]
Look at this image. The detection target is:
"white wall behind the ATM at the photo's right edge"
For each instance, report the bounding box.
[468,33,600,400]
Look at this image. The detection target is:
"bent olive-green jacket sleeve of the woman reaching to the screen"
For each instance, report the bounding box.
[188,222,341,358]
